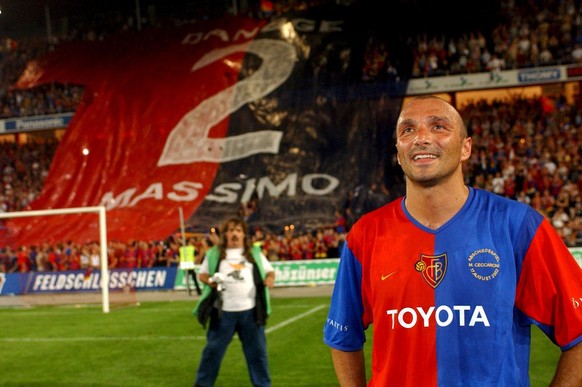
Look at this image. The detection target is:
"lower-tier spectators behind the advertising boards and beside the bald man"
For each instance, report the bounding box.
[0,91,582,272]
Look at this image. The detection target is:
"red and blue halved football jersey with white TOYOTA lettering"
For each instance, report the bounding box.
[324,188,582,387]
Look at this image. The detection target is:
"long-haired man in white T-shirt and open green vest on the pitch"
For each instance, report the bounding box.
[194,218,275,387]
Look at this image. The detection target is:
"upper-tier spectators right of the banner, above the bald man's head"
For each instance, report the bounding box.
[362,0,582,80]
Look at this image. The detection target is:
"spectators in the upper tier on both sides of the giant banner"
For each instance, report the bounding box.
[0,0,582,118]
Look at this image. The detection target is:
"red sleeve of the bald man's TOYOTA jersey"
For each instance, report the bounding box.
[516,219,582,350]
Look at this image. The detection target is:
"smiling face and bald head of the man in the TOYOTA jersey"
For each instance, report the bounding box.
[396,99,471,187]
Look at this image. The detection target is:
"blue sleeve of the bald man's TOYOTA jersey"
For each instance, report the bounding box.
[323,242,366,352]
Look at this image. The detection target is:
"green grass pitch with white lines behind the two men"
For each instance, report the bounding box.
[0,297,559,387]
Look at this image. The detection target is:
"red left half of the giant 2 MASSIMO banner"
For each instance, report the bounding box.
[8,17,278,244]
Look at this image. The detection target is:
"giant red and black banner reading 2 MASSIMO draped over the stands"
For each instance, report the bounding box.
[8,6,408,244]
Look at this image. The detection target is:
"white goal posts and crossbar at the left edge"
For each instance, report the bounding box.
[0,206,109,313]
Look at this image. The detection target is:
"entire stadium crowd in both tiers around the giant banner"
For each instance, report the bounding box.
[0,0,582,272]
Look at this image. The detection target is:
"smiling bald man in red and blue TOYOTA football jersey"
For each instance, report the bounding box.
[324,96,582,387]
